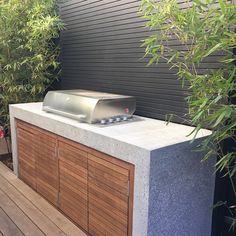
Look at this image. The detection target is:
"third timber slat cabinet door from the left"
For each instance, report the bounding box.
[58,138,88,231]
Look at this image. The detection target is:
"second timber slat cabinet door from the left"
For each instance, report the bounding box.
[35,129,59,206]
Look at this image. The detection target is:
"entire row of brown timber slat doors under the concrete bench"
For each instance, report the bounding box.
[17,121,134,236]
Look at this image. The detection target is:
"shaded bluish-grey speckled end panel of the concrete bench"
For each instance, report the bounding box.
[148,140,215,236]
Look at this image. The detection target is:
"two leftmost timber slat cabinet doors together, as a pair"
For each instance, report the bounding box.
[17,120,59,206]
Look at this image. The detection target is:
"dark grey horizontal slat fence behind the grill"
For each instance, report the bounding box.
[60,0,219,122]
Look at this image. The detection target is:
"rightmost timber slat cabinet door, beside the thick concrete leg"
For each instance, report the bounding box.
[88,152,133,236]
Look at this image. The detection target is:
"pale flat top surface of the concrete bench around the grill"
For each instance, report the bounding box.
[10,103,210,151]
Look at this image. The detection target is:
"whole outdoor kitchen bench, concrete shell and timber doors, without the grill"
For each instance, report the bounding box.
[10,103,215,236]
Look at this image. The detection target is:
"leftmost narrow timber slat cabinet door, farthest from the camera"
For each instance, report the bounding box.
[16,122,38,190]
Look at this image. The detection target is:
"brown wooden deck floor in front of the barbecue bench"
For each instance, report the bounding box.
[0,162,86,236]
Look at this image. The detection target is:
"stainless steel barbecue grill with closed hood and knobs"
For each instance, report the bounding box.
[43,90,136,124]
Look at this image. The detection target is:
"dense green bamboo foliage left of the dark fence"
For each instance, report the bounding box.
[0,0,63,135]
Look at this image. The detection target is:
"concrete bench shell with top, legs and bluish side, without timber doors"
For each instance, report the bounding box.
[10,103,215,236]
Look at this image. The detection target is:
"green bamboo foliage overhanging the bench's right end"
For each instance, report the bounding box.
[141,0,236,229]
